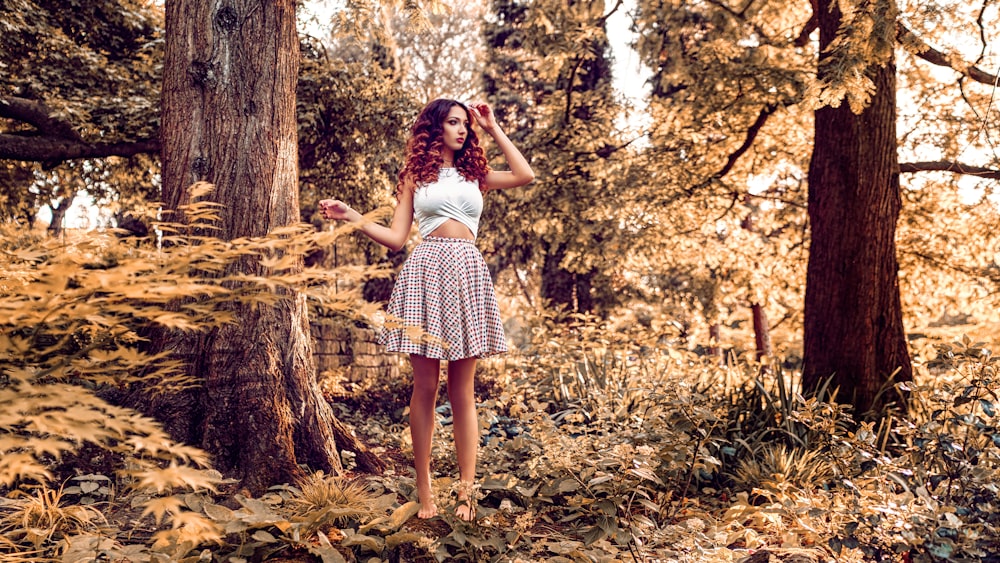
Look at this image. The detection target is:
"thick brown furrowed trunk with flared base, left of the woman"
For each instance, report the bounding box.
[147,0,378,493]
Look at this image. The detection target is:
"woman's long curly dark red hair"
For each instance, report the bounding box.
[396,99,490,193]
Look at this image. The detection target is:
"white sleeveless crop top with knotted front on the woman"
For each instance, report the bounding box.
[413,168,483,237]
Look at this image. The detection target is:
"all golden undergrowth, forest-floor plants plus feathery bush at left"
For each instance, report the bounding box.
[0,204,1000,563]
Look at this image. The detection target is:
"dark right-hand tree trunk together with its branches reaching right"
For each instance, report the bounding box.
[803,0,997,416]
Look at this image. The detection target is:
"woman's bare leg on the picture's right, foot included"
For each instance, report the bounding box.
[448,358,479,520]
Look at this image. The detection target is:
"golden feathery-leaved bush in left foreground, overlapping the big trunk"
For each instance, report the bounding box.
[0,185,388,555]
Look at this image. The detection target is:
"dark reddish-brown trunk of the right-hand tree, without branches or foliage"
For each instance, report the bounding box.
[803,0,912,417]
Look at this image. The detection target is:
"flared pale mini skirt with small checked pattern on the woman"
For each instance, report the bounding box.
[378,237,507,360]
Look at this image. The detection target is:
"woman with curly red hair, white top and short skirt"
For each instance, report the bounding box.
[320,99,535,521]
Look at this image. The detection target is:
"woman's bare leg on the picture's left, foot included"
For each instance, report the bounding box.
[410,355,441,518]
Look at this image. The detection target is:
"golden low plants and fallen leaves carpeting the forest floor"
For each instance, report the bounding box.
[0,310,1000,562]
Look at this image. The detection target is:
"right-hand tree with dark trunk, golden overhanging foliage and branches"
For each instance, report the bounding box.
[637,0,997,415]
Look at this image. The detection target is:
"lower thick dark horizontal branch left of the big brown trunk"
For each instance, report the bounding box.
[0,134,160,163]
